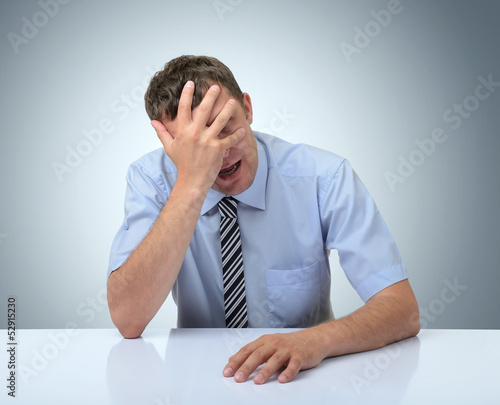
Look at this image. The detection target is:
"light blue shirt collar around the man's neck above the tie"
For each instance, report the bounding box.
[201,139,268,215]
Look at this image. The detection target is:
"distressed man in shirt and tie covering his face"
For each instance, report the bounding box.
[108,56,420,384]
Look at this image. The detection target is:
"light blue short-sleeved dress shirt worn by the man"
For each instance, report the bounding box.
[108,132,407,327]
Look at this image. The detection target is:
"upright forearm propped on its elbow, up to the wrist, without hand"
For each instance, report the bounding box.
[108,182,206,338]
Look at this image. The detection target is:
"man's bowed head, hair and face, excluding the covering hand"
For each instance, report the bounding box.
[144,56,258,195]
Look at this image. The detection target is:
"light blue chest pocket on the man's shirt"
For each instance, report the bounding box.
[266,262,321,328]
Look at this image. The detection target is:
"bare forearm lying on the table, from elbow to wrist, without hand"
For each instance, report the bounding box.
[311,280,420,357]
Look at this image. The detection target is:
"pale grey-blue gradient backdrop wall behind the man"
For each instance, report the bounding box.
[0,0,500,328]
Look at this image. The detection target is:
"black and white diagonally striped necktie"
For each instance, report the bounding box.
[218,197,248,328]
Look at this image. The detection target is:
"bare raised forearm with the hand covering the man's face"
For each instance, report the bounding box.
[108,81,245,337]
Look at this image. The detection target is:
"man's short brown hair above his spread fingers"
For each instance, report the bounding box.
[144,55,243,120]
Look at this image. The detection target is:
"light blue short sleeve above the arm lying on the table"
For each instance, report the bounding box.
[320,160,408,302]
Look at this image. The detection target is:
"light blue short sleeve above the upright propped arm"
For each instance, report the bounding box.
[108,162,166,277]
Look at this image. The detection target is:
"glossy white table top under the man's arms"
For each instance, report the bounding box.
[0,329,500,405]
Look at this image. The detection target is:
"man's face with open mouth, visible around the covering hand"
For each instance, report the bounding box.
[164,87,258,195]
